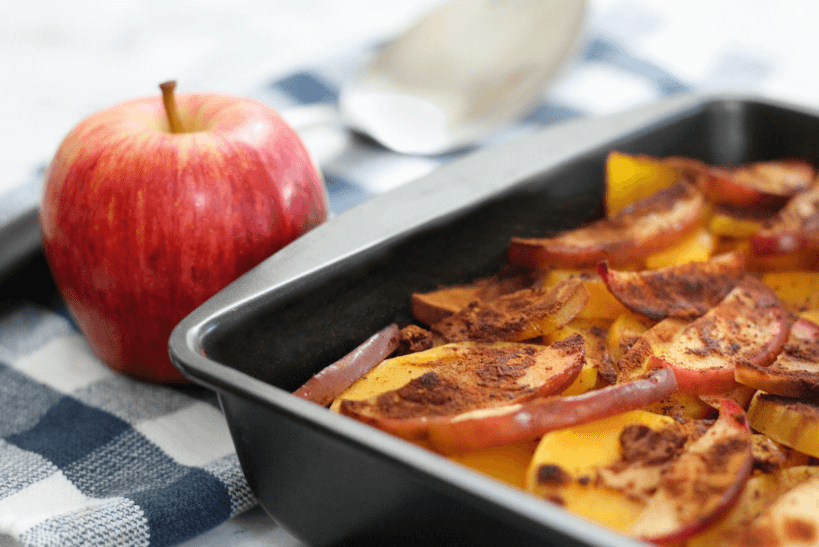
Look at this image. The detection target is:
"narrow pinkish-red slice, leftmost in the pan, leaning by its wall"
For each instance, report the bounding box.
[293,323,399,406]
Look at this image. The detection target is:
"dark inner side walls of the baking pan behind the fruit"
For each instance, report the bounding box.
[201,100,819,391]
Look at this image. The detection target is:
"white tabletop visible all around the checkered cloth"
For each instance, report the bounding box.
[6,0,819,547]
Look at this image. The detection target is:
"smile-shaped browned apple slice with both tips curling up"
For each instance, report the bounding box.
[597,252,745,321]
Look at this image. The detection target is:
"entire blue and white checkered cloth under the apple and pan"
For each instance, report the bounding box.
[0,10,780,547]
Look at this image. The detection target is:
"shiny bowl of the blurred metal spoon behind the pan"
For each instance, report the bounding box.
[339,0,586,154]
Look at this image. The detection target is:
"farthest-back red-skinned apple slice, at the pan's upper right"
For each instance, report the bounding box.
[698,160,816,209]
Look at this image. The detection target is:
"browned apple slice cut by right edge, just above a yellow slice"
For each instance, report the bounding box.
[734,318,819,398]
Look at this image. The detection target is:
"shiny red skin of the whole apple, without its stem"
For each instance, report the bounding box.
[40,94,327,383]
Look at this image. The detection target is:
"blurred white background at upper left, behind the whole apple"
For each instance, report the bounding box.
[0,0,440,196]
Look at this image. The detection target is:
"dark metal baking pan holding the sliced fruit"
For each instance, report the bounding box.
[170,96,819,546]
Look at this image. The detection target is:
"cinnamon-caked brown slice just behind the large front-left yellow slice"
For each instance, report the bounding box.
[432,279,589,342]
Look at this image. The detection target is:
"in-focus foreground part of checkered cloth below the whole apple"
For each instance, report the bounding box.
[0,304,255,547]
